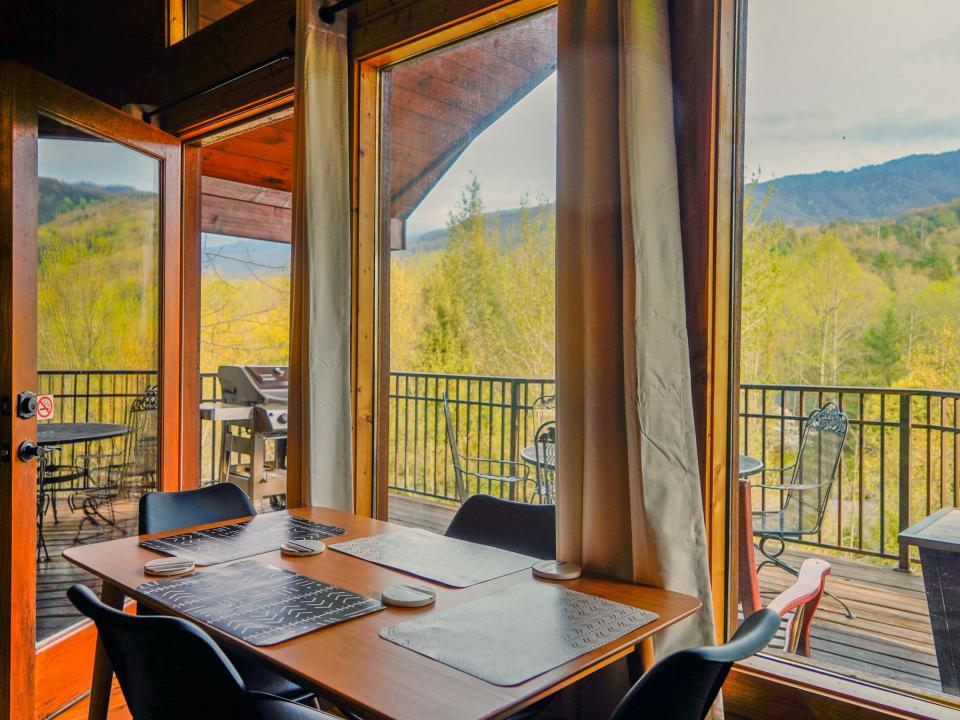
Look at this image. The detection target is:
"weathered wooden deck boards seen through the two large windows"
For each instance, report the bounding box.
[389,495,940,692]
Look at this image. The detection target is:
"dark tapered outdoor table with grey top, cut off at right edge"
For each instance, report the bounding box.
[900,508,960,695]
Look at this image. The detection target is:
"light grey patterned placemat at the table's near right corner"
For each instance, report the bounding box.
[380,582,658,686]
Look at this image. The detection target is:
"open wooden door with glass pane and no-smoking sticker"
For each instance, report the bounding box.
[0,62,182,718]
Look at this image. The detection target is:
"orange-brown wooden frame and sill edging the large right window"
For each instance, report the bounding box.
[724,0,960,718]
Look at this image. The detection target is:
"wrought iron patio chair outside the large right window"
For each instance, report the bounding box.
[752,402,853,618]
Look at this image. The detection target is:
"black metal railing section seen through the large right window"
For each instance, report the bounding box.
[740,385,960,568]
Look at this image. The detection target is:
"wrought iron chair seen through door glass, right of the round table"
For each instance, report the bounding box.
[69,385,159,544]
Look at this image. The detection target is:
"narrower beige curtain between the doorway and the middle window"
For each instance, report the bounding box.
[288,0,353,511]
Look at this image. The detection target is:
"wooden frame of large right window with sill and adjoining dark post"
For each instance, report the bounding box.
[704,0,960,720]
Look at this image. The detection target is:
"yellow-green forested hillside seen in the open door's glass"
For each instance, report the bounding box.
[37,178,159,370]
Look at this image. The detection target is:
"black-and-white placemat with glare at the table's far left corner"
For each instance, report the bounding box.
[140,513,344,565]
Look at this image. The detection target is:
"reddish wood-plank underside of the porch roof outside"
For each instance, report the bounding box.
[203,10,557,239]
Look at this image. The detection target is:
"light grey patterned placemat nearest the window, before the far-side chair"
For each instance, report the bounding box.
[330,530,537,587]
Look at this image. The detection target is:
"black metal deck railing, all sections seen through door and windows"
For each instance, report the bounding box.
[38,370,960,567]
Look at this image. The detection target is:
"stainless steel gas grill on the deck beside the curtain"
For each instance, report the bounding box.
[200,365,289,509]
